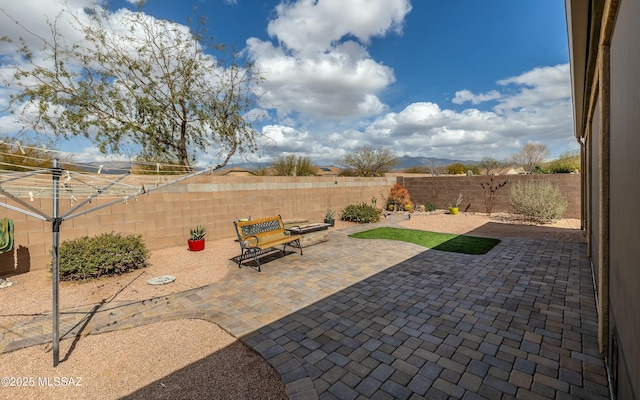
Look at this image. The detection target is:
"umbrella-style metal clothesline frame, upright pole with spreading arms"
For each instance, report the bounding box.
[0,159,215,367]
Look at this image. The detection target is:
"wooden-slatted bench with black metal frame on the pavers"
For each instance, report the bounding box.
[233,215,302,272]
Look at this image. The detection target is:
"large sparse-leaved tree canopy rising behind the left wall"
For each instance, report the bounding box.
[0,4,261,169]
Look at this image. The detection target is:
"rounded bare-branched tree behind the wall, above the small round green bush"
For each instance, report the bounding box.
[336,146,397,176]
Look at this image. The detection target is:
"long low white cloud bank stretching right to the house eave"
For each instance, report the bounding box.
[255,65,576,164]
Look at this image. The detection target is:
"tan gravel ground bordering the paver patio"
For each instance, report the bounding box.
[0,212,585,399]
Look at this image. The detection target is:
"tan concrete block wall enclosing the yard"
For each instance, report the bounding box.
[0,175,580,276]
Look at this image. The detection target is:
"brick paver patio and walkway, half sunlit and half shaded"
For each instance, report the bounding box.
[0,219,609,399]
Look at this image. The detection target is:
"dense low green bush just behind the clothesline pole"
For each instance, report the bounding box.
[58,233,150,281]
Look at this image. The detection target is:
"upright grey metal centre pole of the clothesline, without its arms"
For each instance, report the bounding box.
[51,159,62,367]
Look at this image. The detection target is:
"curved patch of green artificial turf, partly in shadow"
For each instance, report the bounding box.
[349,227,500,254]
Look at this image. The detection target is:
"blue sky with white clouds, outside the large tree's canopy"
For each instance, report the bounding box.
[0,0,578,165]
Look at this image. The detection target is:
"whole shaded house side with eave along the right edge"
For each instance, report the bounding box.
[565,0,640,400]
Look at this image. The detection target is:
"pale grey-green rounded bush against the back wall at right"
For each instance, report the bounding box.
[509,181,567,224]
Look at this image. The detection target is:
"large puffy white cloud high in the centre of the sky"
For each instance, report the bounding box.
[247,0,411,119]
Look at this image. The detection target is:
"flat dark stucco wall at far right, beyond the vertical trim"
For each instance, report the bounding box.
[609,0,640,399]
